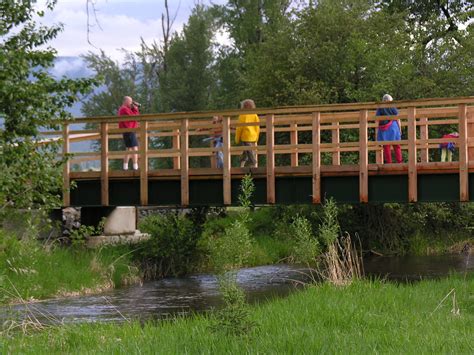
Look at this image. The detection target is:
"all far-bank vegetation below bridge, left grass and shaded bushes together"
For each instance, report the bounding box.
[0,199,474,303]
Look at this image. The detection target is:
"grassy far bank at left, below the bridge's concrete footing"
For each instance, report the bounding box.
[0,233,137,303]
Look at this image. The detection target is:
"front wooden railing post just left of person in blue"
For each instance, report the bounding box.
[359,110,369,203]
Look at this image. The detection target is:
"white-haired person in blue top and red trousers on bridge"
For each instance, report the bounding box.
[375,94,402,163]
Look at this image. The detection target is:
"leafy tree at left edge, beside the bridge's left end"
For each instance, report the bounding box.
[0,0,95,218]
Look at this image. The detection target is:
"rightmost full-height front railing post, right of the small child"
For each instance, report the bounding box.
[458,104,469,202]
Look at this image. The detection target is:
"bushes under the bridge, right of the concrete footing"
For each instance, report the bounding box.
[133,201,474,277]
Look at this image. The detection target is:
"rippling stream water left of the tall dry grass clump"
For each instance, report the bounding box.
[0,265,306,323]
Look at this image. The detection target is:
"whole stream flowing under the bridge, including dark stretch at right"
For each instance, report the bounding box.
[0,255,474,323]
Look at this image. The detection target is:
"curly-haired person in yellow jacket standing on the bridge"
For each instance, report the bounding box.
[235,99,260,168]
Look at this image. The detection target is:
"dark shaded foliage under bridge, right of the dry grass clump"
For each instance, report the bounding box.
[340,203,474,255]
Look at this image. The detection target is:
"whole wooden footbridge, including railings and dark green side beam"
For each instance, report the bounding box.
[45,97,474,206]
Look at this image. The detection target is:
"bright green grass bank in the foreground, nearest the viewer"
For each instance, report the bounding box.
[0,274,474,354]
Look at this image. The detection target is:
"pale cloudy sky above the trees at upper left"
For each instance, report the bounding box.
[39,0,226,60]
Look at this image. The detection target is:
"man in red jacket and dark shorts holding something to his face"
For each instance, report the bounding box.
[118,96,140,170]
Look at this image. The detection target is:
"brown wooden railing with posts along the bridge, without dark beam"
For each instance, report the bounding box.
[39,97,474,206]
